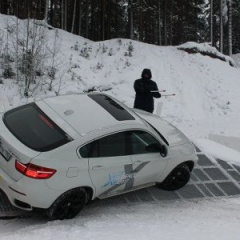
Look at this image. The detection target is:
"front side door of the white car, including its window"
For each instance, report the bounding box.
[128,130,168,187]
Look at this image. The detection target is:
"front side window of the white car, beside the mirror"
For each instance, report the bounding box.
[129,131,160,154]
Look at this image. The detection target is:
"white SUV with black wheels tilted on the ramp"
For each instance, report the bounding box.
[0,93,197,220]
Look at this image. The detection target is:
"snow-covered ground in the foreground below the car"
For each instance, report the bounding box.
[0,199,240,240]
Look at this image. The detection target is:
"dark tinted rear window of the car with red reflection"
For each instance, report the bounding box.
[3,103,72,152]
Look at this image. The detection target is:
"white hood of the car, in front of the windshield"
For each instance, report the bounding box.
[133,109,190,146]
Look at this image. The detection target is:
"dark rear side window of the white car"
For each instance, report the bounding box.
[79,132,127,158]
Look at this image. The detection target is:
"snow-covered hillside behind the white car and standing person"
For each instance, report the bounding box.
[0,12,240,148]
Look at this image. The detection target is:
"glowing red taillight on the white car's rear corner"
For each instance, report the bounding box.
[15,160,56,179]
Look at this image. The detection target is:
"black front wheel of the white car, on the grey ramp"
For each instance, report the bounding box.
[158,164,191,191]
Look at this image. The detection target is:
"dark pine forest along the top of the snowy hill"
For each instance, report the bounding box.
[0,0,240,51]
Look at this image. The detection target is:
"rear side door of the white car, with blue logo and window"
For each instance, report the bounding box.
[80,132,132,198]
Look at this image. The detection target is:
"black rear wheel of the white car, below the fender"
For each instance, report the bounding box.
[47,188,87,220]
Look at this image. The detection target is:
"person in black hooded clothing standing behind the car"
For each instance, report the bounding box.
[134,68,161,113]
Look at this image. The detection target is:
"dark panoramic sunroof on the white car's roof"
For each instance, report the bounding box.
[88,94,135,121]
